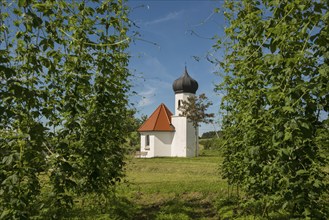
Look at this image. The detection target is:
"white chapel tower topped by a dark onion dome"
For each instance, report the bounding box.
[171,66,199,157]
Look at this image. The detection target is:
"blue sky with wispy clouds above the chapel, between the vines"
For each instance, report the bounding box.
[128,0,225,133]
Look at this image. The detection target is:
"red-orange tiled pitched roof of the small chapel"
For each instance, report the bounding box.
[138,104,175,132]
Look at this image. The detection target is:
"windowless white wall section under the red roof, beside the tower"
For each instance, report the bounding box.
[153,132,174,157]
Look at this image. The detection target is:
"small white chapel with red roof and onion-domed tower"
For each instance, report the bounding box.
[138,67,198,158]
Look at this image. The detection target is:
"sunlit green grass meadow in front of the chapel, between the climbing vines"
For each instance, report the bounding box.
[37,145,328,220]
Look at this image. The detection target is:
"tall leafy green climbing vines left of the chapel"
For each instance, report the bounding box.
[0,0,130,219]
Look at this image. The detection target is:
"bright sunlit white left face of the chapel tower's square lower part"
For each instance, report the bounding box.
[171,116,187,157]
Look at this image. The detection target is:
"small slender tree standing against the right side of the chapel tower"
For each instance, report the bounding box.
[180,93,214,157]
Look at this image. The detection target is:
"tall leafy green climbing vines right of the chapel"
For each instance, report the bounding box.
[214,0,329,219]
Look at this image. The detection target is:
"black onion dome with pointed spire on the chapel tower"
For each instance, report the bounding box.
[172,67,199,94]
